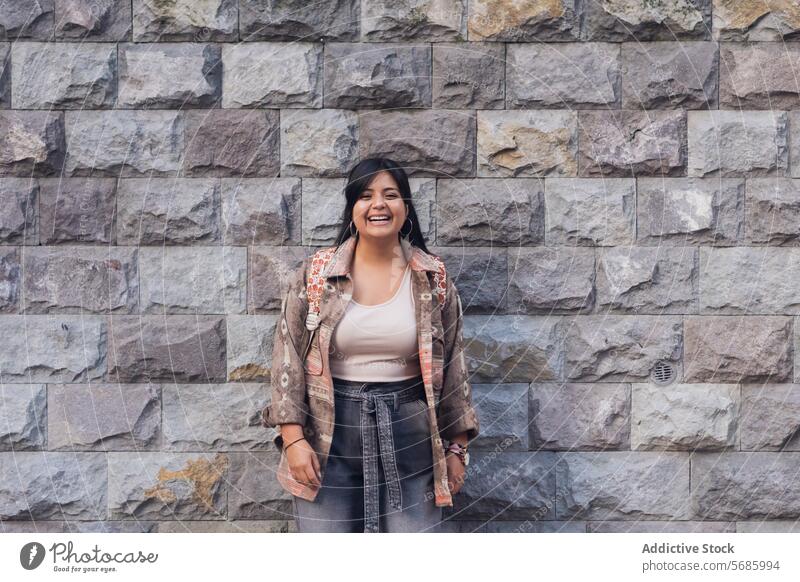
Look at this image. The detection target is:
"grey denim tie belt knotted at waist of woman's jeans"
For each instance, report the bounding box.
[334,377,425,532]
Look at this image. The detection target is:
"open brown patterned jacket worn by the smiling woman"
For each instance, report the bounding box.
[261,237,479,507]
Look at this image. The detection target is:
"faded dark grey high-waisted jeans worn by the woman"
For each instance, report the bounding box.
[293,377,442,532]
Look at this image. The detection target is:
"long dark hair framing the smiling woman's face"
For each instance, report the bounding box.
[336,158,430,253]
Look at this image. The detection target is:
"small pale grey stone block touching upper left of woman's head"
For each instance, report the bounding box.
[281,109,358,178]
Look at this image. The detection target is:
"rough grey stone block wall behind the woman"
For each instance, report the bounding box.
[0,0,800,532]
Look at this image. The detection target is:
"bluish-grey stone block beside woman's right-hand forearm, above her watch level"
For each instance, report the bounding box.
[470,384,528,453]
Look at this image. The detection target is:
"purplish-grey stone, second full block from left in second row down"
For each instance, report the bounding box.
[117,42,222,109]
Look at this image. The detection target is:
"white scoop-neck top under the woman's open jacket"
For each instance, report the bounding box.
[329,265,420,382]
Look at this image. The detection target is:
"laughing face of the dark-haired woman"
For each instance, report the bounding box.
[353,172,408,240]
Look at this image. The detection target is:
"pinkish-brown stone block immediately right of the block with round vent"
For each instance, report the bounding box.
[683,315,792,382]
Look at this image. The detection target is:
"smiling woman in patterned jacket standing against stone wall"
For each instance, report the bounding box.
[262,158,479,532]
